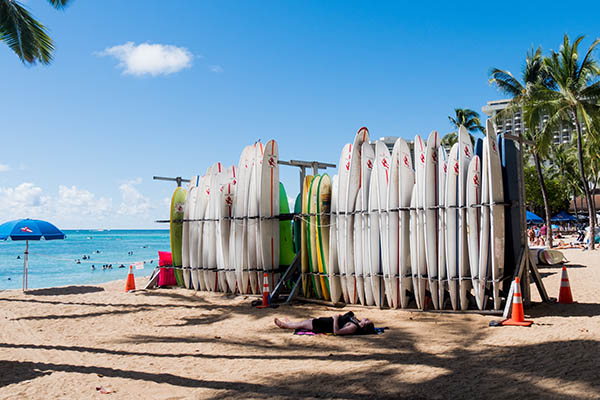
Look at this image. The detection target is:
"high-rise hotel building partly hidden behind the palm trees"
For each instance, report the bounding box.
[481,99,575,145]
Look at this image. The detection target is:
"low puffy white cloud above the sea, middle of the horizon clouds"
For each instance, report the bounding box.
[56,185,112,217]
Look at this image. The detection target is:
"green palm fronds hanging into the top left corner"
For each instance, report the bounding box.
[0,0,71,65]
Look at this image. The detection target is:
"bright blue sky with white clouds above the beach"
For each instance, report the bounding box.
[0,0,600,229]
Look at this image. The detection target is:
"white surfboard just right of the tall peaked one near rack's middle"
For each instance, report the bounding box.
[354,142,375,306]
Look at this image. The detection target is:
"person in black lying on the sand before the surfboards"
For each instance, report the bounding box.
[274,311,375,335]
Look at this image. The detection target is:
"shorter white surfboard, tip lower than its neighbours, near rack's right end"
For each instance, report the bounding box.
[467,156,481,303]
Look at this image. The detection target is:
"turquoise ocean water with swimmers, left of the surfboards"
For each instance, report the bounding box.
[0,230,171,290]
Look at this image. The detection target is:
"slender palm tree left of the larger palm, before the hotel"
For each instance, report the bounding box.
[489,47,552,248]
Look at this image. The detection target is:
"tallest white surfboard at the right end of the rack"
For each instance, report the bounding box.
[486,119,504,310]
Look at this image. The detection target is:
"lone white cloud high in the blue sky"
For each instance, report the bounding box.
[98,42,194,76]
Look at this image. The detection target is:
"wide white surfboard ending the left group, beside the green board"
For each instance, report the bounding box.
[259,140,279,291]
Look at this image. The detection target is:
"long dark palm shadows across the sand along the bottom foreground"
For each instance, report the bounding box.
[0,335,600,399]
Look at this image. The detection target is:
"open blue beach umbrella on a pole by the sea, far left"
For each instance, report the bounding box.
[0,219,65,291]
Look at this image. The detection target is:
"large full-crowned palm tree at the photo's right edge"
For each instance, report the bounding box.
[528,34,600,249]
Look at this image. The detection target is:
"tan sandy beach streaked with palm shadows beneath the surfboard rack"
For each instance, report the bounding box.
[0,250,600,399]
